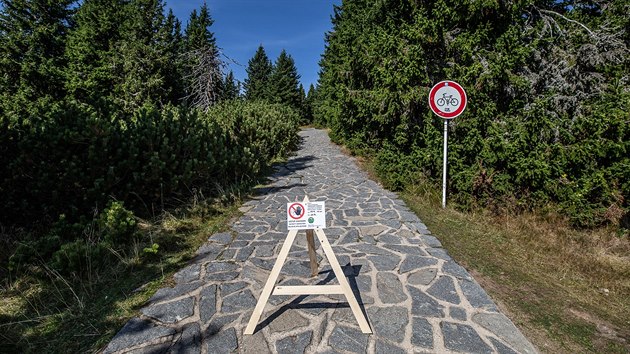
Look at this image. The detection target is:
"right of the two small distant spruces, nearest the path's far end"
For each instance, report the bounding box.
[270,50,303,112]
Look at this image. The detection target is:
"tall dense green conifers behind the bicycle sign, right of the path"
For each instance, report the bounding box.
[315,0,630,227]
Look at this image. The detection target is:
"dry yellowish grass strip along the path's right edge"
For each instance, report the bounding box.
[403,188,630,353]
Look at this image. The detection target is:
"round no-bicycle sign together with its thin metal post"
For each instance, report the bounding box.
[429,81,468,208]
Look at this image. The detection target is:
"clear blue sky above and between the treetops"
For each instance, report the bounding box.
[166,0,341,90]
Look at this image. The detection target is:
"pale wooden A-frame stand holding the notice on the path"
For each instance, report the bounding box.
[243,197,372,334]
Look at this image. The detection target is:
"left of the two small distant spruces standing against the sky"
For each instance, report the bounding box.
[244,45,273,100]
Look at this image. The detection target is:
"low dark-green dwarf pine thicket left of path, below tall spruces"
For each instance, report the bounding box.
[0,100,299,269]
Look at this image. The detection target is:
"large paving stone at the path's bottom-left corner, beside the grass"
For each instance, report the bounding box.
[103,318,175,354]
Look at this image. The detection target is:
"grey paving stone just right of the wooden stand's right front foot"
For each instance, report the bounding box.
[368,307,409,343]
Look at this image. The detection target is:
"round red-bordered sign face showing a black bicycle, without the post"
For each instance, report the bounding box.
[429,81,467,119]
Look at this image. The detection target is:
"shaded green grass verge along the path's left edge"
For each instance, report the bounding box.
[0,202,239,353]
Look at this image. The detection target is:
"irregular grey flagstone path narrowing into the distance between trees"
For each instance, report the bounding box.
[104,129,536,354]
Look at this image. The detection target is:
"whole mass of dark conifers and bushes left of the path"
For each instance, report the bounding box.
[0,0,307,271]
